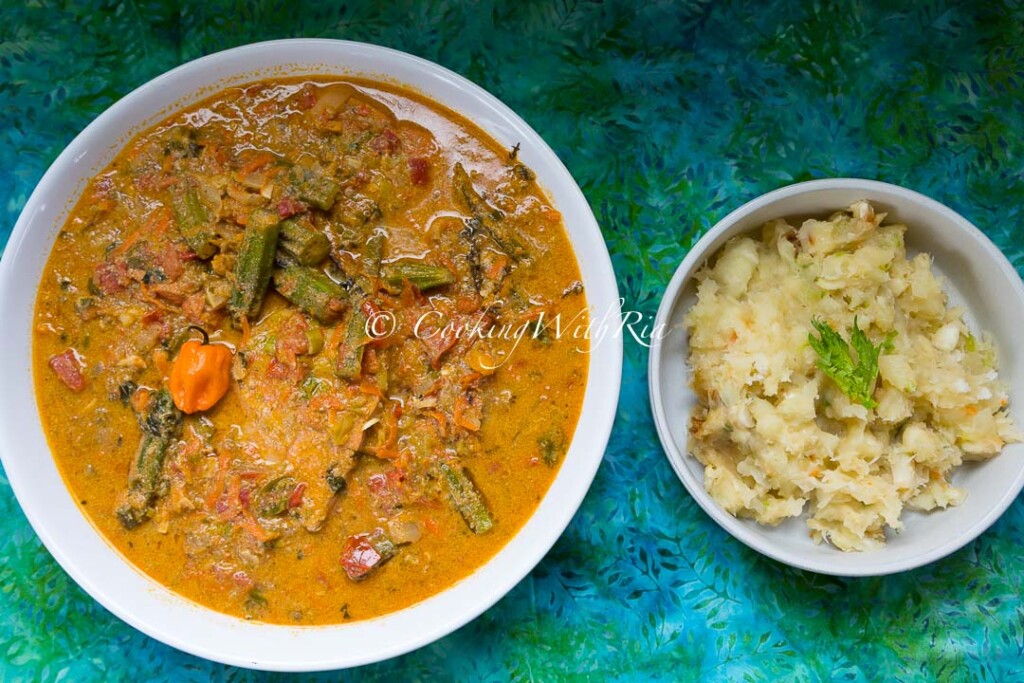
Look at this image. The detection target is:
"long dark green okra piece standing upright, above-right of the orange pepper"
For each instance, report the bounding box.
[228,211,281,321]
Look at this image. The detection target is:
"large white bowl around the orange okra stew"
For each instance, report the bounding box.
[0,40,623,671]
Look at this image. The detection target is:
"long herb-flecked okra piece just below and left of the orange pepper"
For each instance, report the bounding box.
[117,389,184,529]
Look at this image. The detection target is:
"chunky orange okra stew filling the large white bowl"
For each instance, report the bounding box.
[34,79,588,625]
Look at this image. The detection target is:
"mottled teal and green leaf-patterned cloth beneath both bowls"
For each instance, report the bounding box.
[0,0,1024,682]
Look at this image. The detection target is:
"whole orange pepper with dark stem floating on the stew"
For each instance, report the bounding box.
[168,326,231,414]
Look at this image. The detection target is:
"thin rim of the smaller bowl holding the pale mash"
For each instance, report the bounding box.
[647,177,1024,578]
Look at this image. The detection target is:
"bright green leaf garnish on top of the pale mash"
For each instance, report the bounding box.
[807,317,896,408]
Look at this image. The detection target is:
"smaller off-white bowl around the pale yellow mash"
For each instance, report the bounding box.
[649,178,1024,577]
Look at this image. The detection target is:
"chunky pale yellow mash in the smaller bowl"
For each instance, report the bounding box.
[686,201,1019,551]
